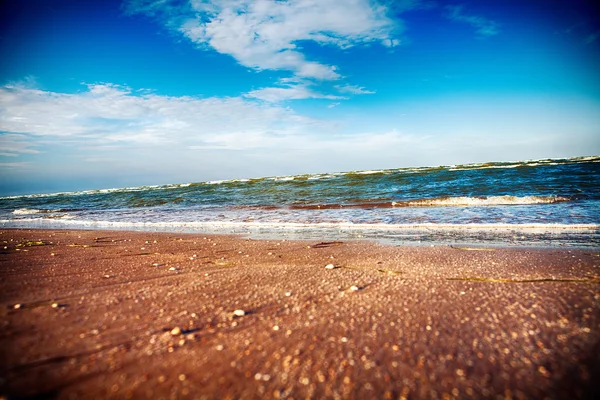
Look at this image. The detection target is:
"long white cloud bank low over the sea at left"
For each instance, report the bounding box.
[0,84,326,154]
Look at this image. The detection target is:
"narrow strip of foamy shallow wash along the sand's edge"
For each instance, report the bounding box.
[0,219,600,251]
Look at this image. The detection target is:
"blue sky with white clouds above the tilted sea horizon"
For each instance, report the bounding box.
[0,0,600,195]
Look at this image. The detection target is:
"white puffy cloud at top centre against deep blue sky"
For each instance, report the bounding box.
[127,0,401,80]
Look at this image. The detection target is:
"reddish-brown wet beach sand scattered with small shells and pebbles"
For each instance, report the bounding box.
[0,230,600,399]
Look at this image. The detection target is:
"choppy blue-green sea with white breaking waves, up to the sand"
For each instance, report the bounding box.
[0,156,600,248]
